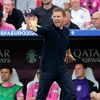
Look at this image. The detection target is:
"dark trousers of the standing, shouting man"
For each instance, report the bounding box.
[36,71,76,100]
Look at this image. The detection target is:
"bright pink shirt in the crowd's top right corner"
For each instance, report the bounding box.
[80,0,100,15]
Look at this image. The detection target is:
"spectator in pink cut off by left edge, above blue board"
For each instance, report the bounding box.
[0,10,15,30]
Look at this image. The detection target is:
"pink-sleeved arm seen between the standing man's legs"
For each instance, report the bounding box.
[46,83,59,100]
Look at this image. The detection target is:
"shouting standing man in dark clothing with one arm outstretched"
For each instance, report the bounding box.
[29,7,76,100]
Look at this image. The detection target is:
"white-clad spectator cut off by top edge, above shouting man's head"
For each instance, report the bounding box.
[52,0,70,8]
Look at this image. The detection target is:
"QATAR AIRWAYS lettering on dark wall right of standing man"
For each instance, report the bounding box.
[73,49,100,63]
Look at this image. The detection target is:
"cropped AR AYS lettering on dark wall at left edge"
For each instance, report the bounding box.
[0,49,10,63]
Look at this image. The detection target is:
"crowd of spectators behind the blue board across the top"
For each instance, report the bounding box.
[0,0,100,30]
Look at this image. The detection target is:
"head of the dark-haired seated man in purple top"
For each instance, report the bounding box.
[74,60,87,79]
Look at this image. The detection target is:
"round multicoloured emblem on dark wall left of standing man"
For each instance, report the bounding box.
[26,49,38,63]
